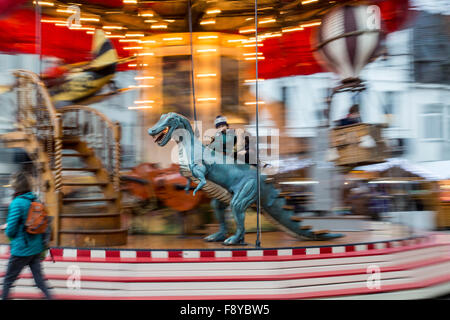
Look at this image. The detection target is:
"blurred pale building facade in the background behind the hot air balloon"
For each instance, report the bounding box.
[255,12,450,162]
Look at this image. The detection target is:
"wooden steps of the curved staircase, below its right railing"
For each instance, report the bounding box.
[59,136,127,247]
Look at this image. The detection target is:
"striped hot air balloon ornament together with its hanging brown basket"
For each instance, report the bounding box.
[316,5,386,169]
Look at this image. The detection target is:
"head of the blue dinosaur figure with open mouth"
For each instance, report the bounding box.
[148,112,192,147]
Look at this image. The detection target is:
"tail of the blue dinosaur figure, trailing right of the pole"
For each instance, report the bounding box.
[261,178,343,240]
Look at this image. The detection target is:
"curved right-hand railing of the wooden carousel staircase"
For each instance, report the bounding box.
[58,105,121,192]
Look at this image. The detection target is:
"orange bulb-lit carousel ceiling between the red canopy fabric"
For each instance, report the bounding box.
[34,0,354,33]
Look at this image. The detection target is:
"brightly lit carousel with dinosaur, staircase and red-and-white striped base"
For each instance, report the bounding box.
[0,0,450,300]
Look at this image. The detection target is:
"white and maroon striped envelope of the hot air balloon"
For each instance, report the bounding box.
[317,5,382,80]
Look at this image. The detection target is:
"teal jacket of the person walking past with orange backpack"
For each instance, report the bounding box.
[5,192,44,257]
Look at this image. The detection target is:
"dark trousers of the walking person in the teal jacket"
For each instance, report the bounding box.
[2,254,52,300]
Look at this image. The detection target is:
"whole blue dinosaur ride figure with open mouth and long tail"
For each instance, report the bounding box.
[148,112,343,245]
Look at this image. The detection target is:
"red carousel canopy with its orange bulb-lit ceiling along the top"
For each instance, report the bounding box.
[0,0,414,79]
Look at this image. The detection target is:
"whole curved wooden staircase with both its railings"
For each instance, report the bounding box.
[0,70,127,247]
